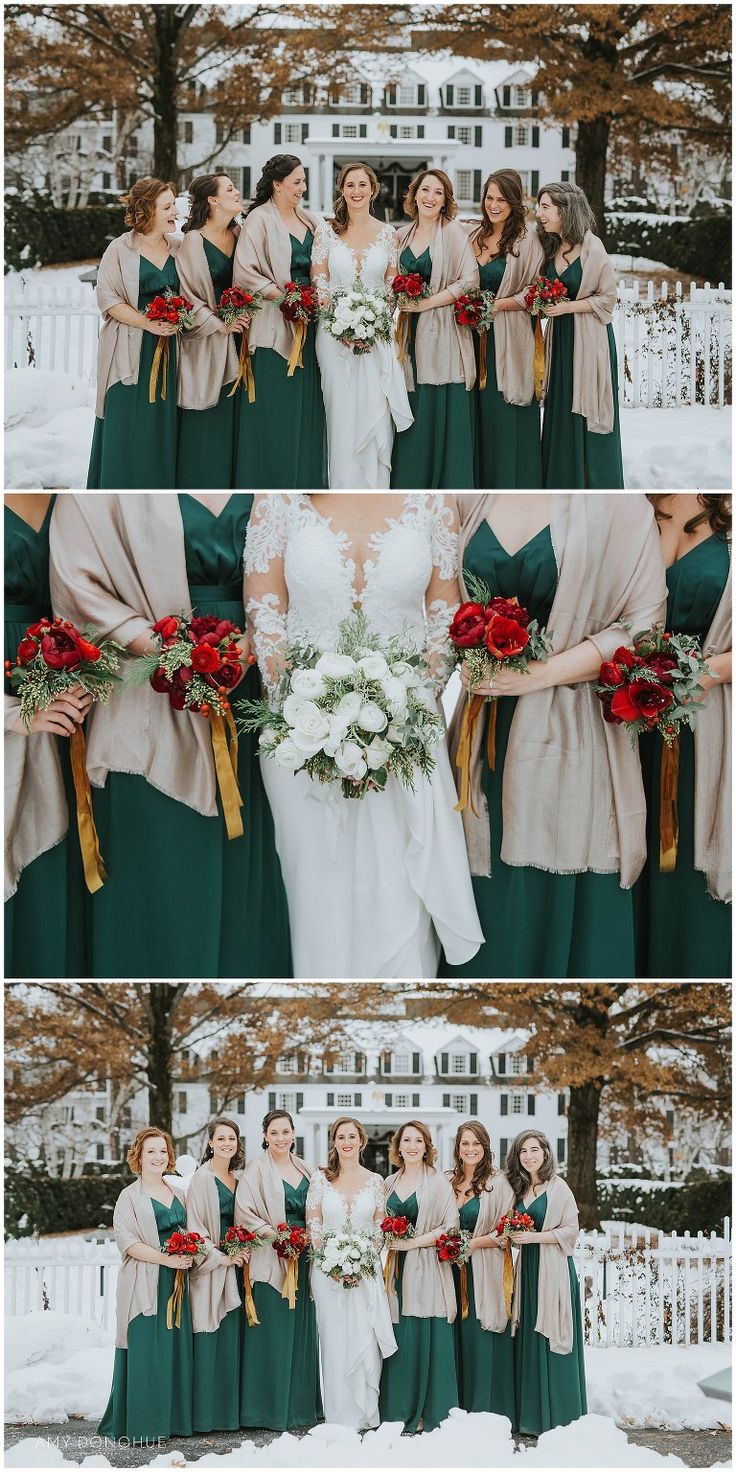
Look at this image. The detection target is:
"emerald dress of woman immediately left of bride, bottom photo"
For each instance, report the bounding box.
[240,1176,322,1431]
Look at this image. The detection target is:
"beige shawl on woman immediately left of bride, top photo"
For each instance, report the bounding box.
[233,199,316,358]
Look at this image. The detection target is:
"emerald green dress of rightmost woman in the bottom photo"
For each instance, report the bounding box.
[514,1191,587,1437]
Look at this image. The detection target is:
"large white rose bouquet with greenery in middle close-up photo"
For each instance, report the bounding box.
[234,611,445,798]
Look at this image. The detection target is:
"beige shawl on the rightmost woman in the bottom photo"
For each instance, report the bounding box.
[512,1176,580,1354]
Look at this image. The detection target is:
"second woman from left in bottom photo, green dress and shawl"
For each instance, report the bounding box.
[187,1116,247,1431]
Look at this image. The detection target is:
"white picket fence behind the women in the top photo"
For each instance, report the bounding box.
[4,275,732,408]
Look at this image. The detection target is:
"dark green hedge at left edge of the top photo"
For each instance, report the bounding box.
[4,193,125,271]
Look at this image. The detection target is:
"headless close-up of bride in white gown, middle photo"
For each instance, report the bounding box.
[246,493,483,979]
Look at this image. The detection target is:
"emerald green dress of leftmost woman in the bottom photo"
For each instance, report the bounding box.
[97,1197,194,1443]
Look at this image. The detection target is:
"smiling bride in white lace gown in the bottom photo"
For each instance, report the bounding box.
[306,1117,396,1431]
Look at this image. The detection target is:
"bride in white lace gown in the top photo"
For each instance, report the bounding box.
[312,163,414,490]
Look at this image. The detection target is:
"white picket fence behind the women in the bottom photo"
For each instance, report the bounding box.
[4,1219,732,1348]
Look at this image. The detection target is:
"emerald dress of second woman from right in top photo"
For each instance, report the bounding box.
[473,256,541,490]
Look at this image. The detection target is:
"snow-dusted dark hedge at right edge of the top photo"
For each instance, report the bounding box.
[605,213,732,287]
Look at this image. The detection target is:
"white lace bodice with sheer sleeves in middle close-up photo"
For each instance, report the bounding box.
[246,493,459,693]
